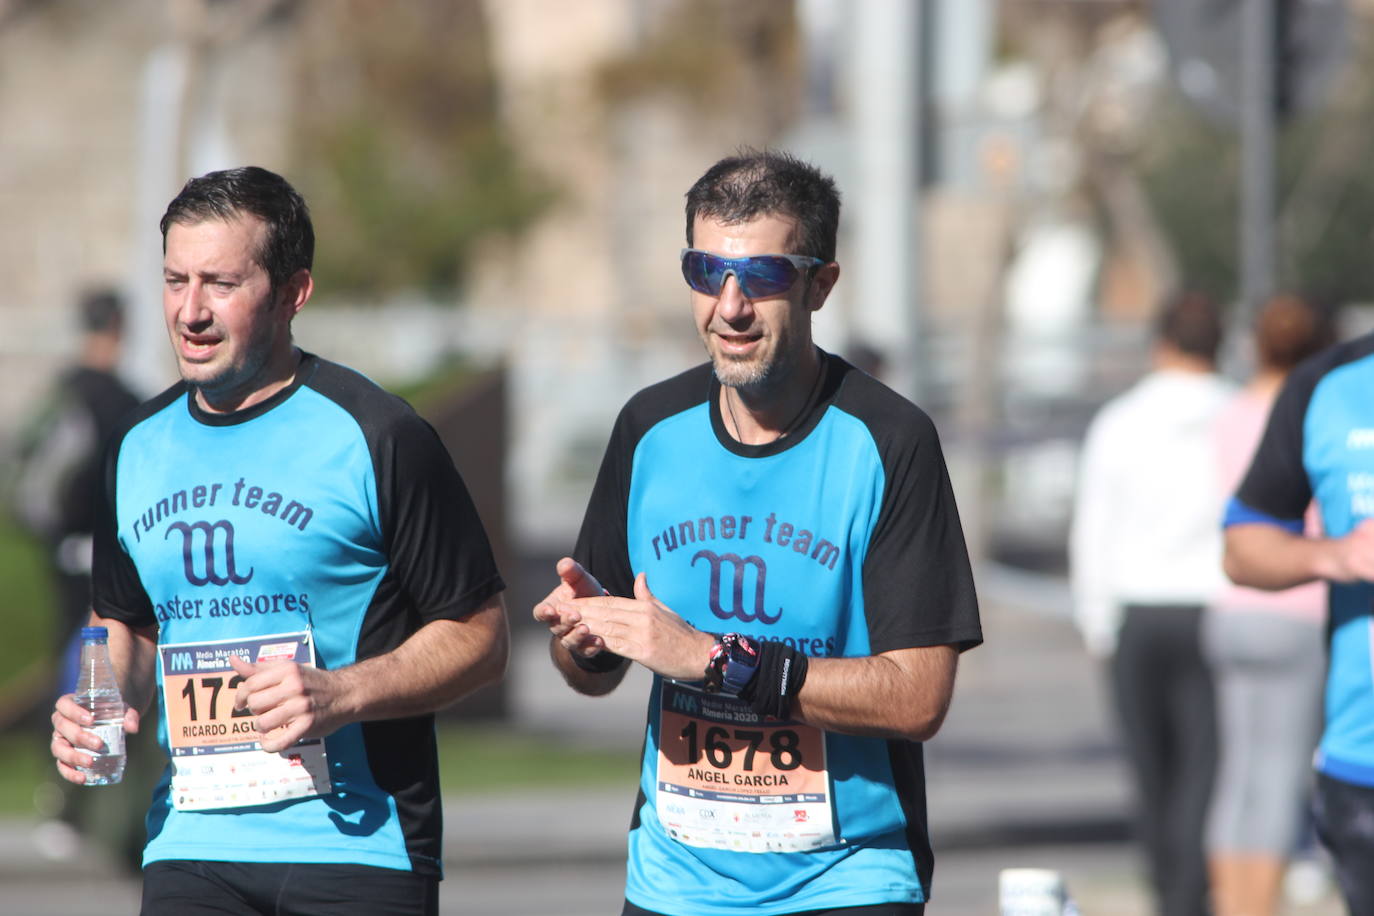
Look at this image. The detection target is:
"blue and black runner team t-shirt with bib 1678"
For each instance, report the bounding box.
[576,357,982,915]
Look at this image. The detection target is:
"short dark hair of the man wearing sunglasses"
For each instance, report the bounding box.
[687,150,840,261]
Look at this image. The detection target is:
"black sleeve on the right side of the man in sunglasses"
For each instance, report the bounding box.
[863,411,982,654]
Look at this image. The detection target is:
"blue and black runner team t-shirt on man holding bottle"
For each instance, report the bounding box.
[93,354,503,875]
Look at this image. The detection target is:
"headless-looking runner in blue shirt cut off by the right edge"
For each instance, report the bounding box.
[1226,304,1374,916]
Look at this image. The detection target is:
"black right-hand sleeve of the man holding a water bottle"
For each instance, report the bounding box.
[372,408,506,622]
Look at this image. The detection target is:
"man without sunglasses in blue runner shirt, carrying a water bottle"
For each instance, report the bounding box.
[51,168,508,916]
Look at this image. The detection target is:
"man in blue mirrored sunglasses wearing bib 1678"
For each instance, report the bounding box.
[534,151,982,916]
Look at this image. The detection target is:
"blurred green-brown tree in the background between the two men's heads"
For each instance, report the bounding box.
[293,0,555,297]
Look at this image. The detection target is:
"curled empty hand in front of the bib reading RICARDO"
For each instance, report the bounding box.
[229,655,345,753]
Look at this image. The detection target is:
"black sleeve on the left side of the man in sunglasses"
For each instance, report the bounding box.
[573,407,638,596]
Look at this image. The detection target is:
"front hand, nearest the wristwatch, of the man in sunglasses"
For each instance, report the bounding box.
[559,573,716,681]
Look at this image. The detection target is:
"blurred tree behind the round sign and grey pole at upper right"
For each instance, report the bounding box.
[1000,0,1374,313]
